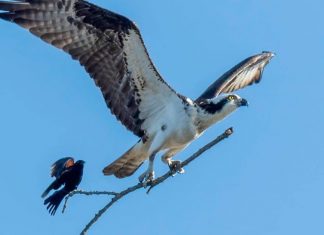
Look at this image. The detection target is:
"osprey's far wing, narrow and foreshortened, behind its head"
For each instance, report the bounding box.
[197,52,274,100]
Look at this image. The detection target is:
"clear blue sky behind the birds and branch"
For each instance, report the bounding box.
[0,0,324,235]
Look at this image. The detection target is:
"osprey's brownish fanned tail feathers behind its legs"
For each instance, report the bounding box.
[103,141,148,178]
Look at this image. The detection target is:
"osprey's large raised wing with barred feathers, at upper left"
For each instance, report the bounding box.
[0,0,182,137]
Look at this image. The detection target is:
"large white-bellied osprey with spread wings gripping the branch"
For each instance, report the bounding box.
[0,0,274,182]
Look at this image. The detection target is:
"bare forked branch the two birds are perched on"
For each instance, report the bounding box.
[63,128,233,235]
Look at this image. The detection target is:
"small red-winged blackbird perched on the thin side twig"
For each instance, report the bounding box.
[42,157,84,215]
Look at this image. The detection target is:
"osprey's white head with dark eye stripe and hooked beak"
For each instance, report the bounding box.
[199,94,248,115]
